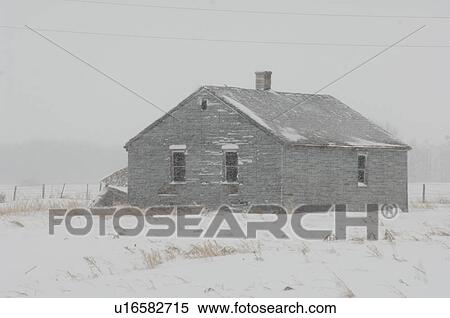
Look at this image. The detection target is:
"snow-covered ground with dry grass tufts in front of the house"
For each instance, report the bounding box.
[0,205,450,297]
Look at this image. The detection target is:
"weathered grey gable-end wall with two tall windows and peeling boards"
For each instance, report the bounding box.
[128,91,283,208]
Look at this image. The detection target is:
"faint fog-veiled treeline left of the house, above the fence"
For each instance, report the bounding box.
[0,141,127,186]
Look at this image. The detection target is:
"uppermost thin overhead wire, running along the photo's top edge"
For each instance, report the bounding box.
[65,0,450,20]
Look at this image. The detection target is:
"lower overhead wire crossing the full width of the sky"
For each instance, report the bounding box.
[0,25,450,48]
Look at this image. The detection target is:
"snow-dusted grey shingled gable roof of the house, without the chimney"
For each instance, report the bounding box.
[125,86,410,149]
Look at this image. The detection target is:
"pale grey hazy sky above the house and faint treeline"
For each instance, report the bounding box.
[0,0,450,147]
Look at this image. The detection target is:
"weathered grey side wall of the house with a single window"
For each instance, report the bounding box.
[283,146,408,211]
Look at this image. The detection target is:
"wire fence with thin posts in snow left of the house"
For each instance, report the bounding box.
[0,183,101,202]
